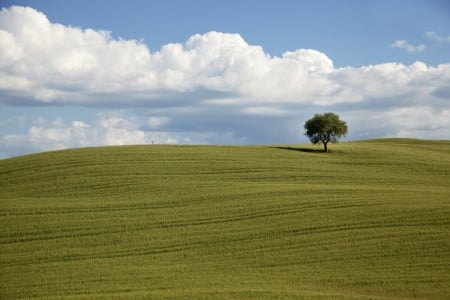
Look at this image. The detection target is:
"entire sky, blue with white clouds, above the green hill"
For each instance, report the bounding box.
[0,0,450,157]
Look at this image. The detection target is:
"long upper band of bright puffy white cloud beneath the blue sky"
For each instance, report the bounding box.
[0,7,446,109]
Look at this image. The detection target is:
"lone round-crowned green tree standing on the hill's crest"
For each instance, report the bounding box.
[305,112,348,152]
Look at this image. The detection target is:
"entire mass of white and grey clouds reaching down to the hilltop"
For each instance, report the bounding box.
[0,7,450,157]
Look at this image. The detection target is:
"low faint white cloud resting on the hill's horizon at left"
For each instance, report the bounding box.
[0,112,179,155]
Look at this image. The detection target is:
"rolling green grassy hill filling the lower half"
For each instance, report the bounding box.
[0,139,450,299]
